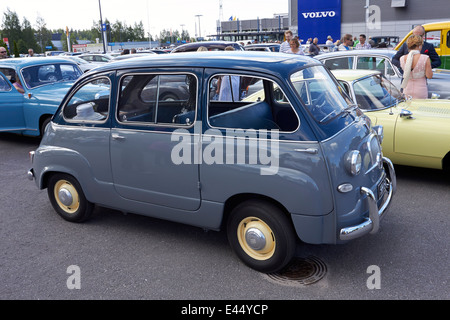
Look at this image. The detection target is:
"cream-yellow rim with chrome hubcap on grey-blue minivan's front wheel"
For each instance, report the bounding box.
[237,217,276,260]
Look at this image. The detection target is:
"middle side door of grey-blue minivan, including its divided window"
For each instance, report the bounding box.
[110,69,201,211]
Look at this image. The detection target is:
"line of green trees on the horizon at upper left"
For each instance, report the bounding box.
[0,8,192,57]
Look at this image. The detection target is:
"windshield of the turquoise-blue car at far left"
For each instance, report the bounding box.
[21,63,82,89]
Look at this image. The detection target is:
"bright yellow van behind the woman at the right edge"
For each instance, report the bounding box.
[395,21,450,69]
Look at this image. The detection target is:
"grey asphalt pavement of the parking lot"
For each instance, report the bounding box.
[0,133,450,302]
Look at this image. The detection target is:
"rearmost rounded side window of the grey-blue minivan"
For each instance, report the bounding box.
[63,78,111,122]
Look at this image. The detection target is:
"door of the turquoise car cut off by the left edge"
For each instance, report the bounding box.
[0,72,25,131]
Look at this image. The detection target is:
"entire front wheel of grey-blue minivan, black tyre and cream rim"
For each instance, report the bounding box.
[227,200,296,273]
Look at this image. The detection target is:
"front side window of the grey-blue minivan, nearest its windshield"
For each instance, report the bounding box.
[208,74,299,132]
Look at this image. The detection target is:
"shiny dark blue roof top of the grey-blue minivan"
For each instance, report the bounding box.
[86,51,321,74]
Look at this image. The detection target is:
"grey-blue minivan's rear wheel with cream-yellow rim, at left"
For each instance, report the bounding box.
[47,174,94,222]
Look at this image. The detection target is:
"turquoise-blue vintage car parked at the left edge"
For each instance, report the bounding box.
[0,57,82,136]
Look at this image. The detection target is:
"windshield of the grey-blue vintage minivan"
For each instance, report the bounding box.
[291,66,351,124]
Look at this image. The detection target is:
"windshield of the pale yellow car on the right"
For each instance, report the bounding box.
[353,75,403,110]
